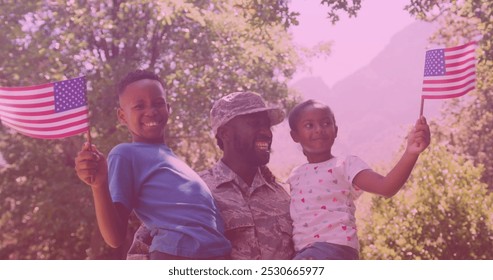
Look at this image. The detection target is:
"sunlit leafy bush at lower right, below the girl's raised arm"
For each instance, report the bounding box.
[358,144,493,260]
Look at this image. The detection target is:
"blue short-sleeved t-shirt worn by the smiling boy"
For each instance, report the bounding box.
[108,143,231,258]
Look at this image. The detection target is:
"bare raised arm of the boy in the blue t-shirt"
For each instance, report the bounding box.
[75,145,130,248]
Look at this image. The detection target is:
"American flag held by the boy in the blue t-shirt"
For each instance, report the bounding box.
[0,77,89,139]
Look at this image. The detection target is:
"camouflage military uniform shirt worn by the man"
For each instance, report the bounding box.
[127,161,294,260]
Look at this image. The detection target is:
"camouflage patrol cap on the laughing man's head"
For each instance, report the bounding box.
[210,92,284,135]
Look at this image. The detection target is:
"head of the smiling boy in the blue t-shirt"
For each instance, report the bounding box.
[118,79,169,143]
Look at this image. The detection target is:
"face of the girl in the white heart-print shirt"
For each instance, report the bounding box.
[291,104,337,163]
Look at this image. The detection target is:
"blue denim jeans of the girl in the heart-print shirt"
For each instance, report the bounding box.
[293,242,359,260]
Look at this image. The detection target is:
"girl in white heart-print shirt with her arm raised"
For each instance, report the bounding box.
[288,100,430,260]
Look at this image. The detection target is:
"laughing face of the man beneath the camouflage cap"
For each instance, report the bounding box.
[225,112,272,166]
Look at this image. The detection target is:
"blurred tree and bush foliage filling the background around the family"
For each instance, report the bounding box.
[0,0,493,259]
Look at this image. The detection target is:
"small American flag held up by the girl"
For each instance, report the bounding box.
[422,42,477,99]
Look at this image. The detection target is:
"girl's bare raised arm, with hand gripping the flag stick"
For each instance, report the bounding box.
[353,117,430,197]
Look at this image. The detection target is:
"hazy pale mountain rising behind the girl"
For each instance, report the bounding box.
[269,22,442,178]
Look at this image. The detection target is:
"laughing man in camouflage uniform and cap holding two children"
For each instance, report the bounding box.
[128,92,294,260]
